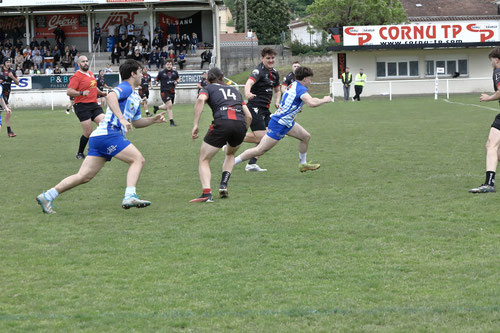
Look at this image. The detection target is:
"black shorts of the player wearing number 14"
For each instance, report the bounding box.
[203,119,247,148]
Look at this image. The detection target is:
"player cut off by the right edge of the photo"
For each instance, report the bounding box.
[469,47,500,193]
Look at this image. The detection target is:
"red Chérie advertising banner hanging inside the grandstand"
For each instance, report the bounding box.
[35,14,88,38]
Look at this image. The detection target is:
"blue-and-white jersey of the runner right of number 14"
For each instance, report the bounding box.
[271,81,309,127]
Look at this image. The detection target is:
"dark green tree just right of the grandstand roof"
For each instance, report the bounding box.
[234,0,291,44]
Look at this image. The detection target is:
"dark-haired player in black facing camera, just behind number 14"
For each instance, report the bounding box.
[244,47,281,171]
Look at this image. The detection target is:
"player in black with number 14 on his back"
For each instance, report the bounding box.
[190,68,252,202]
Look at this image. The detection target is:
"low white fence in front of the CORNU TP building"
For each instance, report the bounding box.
[330,77,493,100]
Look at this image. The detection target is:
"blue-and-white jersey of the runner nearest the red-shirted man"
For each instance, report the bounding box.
[90,81,141,137]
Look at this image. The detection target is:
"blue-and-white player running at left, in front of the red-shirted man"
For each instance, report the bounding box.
[36,60,165,214]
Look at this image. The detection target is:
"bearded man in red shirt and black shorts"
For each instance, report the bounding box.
[66,55,106,159]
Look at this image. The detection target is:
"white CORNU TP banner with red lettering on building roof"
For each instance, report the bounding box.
[343,21,500,47]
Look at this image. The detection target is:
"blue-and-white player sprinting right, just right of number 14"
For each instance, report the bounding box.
[235,67,332,172]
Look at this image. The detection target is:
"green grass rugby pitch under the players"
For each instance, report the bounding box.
[0,96,500,332]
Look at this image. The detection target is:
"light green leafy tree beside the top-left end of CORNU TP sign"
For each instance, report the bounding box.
[307,0,408,30]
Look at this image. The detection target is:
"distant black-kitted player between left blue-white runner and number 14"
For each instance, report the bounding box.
[154,59,180,126]
